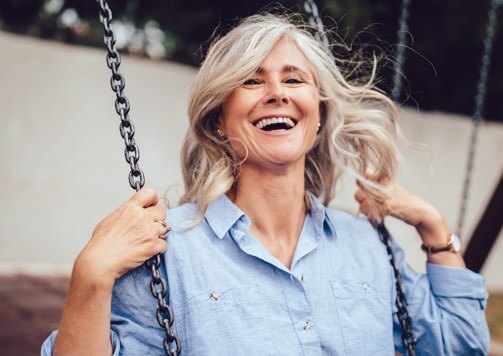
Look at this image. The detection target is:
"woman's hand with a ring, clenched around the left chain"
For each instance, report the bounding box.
[74,188,168,288]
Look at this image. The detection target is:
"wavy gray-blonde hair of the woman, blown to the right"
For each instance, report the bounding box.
[180,14,399,214]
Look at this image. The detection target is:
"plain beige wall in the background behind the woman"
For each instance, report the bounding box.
[0,32,503,290]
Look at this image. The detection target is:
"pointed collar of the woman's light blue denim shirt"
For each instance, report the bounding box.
[205,193,335,239]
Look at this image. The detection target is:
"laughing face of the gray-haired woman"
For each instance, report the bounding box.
[218,37,320,168]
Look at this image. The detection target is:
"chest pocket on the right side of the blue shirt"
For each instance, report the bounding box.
[331,281,394,356]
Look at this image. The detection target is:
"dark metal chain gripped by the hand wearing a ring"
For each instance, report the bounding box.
[96,0,182,356]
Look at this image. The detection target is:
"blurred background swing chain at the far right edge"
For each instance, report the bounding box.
[456,0,503,236]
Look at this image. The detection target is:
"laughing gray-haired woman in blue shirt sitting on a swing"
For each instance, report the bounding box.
[43,15,489,355]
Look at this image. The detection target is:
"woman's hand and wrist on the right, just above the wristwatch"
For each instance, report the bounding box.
[355,181,450,246]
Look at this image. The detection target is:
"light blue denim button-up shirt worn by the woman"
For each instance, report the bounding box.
[42,196,489,356]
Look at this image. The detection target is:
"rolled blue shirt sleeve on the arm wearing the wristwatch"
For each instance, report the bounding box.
[392,236,490,356]
